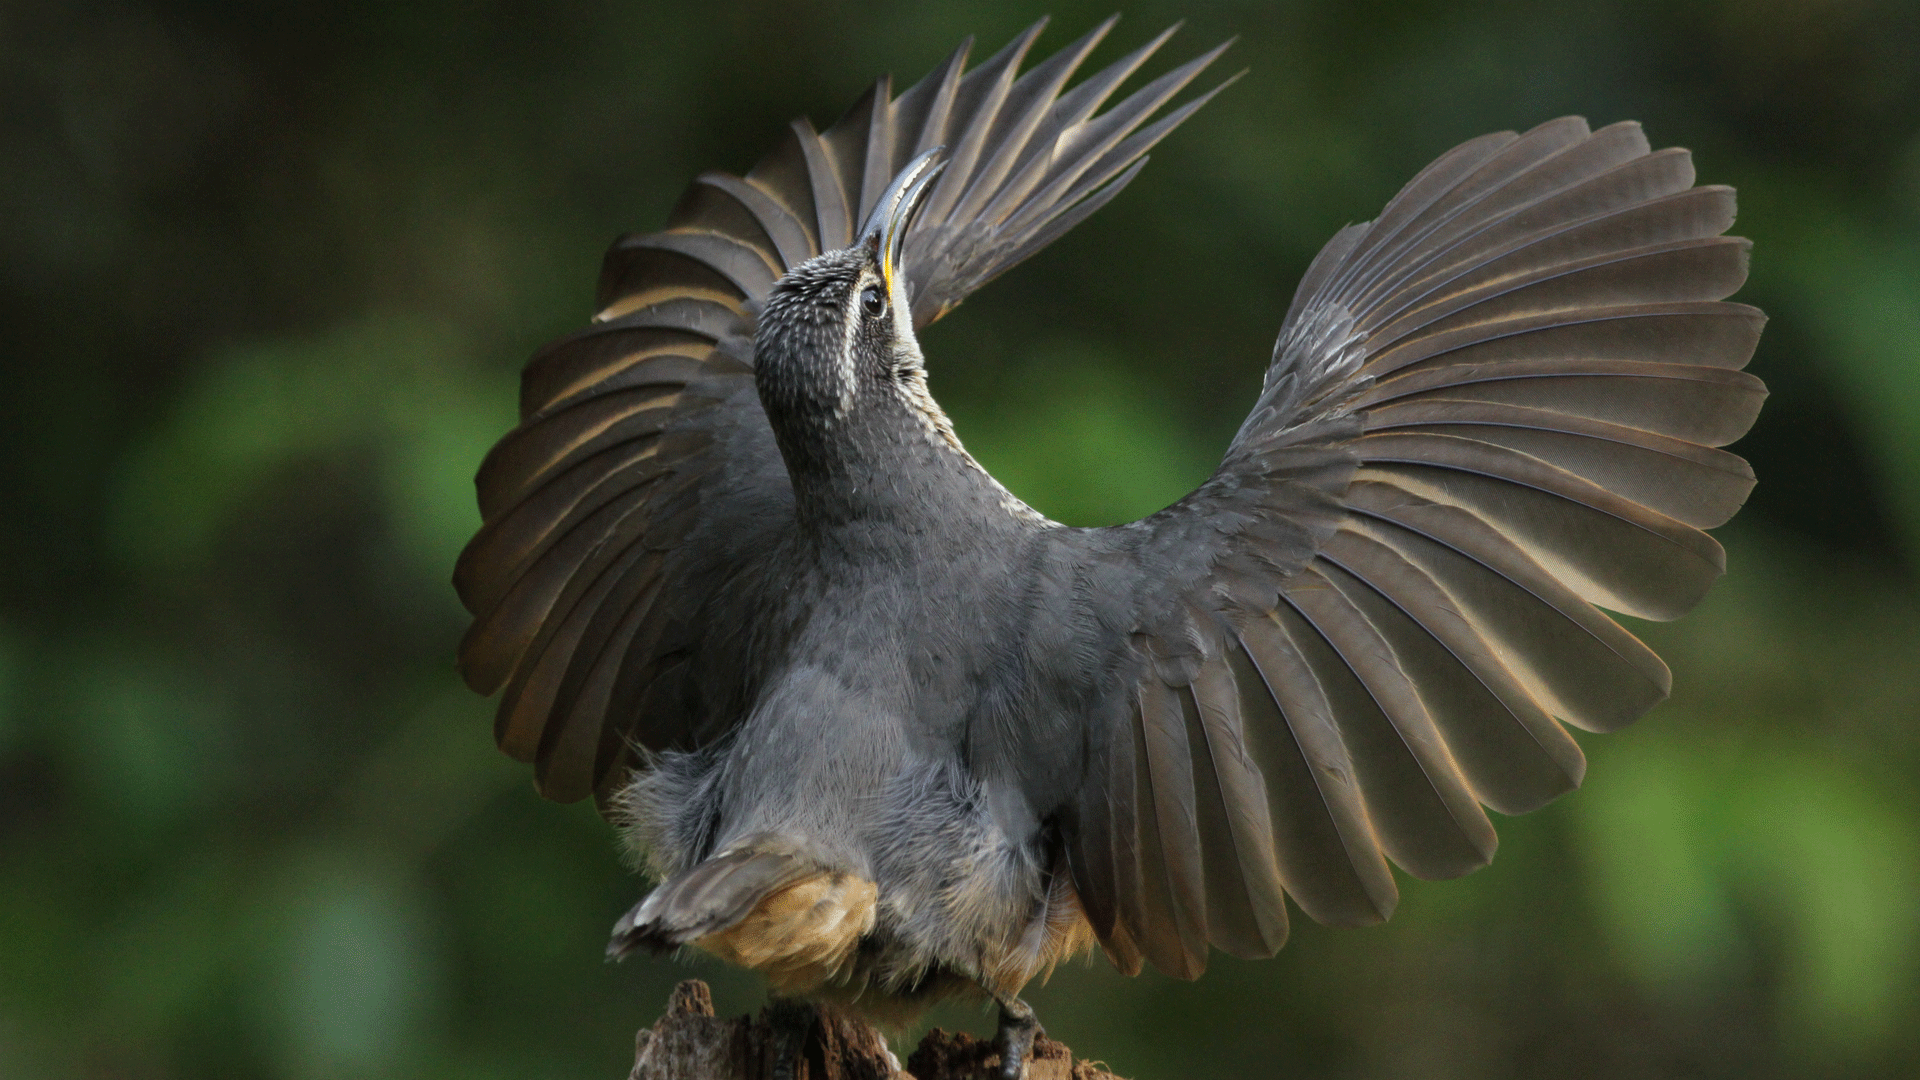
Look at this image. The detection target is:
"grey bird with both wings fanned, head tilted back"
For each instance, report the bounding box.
[455,19,1766,1080]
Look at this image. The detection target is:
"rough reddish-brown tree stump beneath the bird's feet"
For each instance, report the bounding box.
[628,978,1119,1080]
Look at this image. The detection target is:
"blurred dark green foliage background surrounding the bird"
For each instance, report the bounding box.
[0,0,1920,1080]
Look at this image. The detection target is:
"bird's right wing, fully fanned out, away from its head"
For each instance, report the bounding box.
[1069,117,1764,976]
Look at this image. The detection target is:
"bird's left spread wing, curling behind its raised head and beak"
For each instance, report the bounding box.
[453,19,1219,799]
